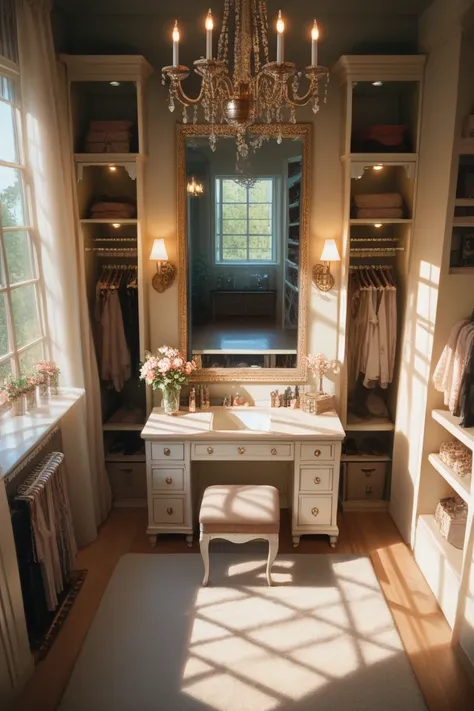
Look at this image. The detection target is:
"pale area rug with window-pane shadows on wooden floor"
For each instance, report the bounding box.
[59,552,426,711]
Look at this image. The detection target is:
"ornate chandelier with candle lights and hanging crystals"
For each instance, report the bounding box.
[162,0,329,159]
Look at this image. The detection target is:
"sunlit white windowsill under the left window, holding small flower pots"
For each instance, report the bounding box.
[0,388,85,480]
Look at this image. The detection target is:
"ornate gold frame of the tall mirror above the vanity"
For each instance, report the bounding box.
[176,123,313,384]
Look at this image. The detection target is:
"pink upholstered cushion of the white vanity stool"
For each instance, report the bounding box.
[199,484,280,533]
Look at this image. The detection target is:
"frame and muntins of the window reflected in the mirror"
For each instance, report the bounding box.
[213,175,281,267]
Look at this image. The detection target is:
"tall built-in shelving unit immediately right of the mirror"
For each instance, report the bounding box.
[335,55,425,510]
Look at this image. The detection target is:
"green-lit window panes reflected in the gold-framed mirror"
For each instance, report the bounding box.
[215,178,277,264]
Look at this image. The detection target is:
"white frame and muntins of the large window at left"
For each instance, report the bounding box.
[0,57,49,381]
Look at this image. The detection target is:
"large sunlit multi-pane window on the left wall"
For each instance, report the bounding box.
[0,63,45,382]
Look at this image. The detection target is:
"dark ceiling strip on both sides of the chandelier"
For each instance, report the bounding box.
[53,0,433,17]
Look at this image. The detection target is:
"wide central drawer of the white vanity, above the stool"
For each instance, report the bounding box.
[191,442,293,460]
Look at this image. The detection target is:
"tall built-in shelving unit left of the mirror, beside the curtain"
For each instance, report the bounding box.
[61,55,152,505]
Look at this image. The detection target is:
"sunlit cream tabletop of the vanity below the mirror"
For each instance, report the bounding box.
[141,407,345,441]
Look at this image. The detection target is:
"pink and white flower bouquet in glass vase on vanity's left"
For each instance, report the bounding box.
[140,346,196,390]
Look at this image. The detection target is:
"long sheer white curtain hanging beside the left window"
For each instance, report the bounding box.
[17,0,111,545]
